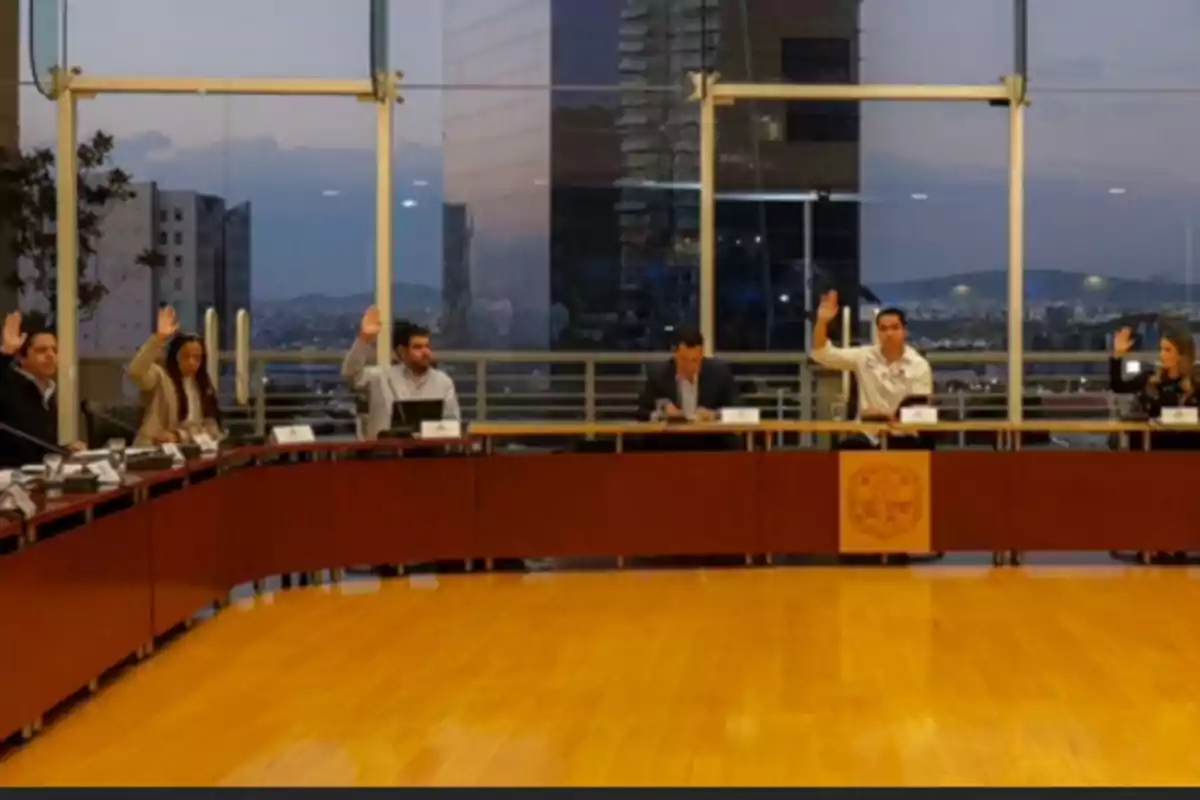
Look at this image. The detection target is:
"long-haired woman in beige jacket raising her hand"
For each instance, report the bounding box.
[130,308,221,447]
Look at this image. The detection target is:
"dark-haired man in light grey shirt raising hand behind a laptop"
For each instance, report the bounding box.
[342,306,462,439]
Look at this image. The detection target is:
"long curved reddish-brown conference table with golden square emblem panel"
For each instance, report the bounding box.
[0,421,1200,740]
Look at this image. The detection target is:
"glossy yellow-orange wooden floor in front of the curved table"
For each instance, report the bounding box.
[0,567,1200,786]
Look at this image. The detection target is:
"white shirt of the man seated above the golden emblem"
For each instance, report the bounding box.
[812,343,934,419]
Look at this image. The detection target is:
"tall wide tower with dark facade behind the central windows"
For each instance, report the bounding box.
[443,0,859,349]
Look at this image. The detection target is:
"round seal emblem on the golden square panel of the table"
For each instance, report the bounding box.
[846,463,925,541]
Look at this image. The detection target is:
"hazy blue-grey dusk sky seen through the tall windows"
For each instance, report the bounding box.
[22,0,1200,297]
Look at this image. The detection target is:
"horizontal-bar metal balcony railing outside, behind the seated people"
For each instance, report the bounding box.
[80,350,1121,448]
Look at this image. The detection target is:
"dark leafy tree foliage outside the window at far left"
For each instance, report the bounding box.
[0,131,167,320]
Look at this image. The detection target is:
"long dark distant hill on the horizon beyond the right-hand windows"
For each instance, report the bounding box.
[868,270,1200,308]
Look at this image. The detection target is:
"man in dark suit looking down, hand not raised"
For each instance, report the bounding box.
[637,330,742,450]
